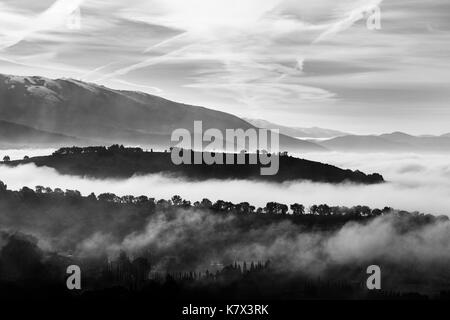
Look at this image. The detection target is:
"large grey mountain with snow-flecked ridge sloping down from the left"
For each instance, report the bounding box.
[0,75,325,151]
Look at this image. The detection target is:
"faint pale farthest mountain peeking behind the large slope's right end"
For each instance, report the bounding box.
[244,118,348,139]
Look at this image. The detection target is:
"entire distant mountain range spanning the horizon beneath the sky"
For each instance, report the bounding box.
[0,74,450,152]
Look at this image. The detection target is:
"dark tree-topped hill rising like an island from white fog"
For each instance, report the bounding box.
[2,145,384,184]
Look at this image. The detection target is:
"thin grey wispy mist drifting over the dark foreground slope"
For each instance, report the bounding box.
[77,210,450,275]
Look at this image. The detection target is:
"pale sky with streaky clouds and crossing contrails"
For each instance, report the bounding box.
[0,0,450,134]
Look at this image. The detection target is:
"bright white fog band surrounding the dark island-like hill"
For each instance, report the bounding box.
[0,150,450,215]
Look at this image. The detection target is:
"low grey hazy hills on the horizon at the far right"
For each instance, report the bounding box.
[318,132,450,152]
